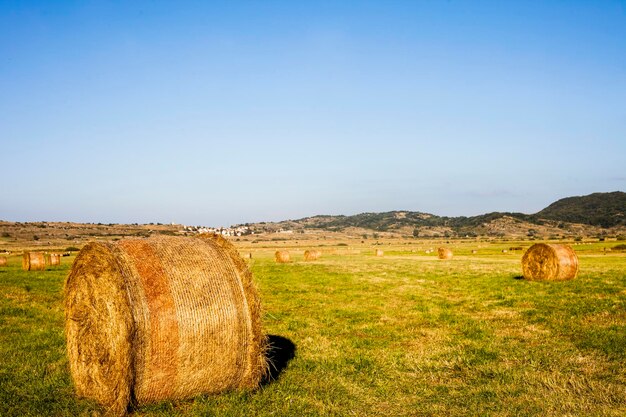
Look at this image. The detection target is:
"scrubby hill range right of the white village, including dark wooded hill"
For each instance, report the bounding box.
[239,191,626,236]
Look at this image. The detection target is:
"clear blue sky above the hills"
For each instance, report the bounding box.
[0,0,626,226]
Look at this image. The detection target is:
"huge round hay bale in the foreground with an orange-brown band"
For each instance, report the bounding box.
[65,236,267,415]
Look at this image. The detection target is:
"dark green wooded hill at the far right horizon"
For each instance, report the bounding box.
[535,191,626,228]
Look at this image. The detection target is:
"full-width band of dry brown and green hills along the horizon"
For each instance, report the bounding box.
[0,191,626,247]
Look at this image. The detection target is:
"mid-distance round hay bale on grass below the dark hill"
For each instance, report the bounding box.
[522,243,578,281]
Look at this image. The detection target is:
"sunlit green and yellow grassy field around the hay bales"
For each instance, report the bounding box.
[0,242,626,417]
